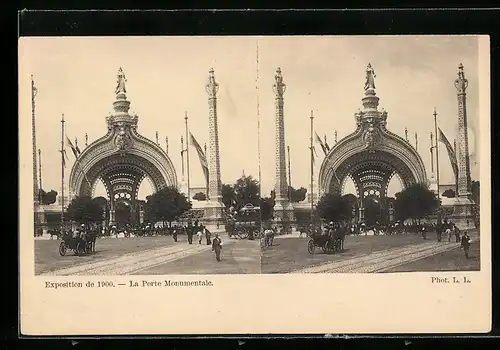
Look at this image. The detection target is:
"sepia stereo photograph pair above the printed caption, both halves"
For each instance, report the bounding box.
[28,36,480,275]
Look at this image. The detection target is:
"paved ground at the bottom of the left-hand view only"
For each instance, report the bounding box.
[35,236,260,276]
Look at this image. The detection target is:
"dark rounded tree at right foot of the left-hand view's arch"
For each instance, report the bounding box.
[145,186,191,222]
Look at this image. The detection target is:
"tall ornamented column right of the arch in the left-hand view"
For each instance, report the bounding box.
[204,69,224,230]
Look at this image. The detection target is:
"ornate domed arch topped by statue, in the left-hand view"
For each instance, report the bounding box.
[69,68,178,203]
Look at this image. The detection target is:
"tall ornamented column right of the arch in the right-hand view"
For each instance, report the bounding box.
[453,63,473,228]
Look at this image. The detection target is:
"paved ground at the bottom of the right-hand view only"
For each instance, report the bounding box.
[262,234,479,273]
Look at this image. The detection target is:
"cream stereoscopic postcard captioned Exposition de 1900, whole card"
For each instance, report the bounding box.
[19,35,492,336]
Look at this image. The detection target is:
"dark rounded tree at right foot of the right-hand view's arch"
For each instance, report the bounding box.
[394,184,439,220]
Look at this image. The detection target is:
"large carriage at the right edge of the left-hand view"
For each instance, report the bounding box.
[226,204,261,239]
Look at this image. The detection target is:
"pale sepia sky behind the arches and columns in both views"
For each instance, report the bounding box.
[19,36,479,197]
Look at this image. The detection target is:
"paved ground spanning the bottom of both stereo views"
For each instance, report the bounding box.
[35,232,479,276]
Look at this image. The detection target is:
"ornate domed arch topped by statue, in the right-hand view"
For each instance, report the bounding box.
[318,65,427,197]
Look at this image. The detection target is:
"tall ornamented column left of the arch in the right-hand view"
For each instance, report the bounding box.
[273,67,294,226]
